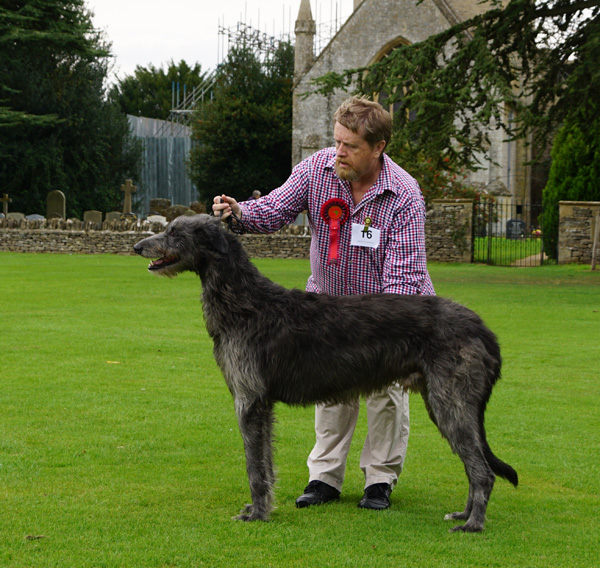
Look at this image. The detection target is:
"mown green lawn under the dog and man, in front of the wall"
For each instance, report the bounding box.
[0,253,600,568]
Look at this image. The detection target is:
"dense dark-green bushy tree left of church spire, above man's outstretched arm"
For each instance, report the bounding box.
[190,43,294,202]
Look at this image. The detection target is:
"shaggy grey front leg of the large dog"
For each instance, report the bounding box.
[235,399,275,521]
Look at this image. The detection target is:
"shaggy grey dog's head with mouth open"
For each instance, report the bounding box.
[133,214,229,277]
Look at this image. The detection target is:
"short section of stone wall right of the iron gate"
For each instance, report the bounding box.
[558,201,600,264]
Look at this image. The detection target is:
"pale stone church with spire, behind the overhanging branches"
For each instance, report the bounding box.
[292,0,531,204]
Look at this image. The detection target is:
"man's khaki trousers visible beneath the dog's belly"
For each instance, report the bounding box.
[307,384,409,491]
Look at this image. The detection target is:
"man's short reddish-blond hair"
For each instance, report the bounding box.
[333,96,392,147]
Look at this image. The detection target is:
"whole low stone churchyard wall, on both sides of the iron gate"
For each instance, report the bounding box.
[0,199,600,264]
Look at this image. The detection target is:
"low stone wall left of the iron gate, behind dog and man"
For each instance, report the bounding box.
[0,200,472,262]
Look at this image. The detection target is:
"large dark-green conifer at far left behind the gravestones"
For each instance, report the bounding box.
[0,0,141,216]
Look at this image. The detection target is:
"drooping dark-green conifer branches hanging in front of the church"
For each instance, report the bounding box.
[316,0,600,175]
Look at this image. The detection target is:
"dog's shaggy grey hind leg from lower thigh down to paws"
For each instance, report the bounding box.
[426,384,496,532]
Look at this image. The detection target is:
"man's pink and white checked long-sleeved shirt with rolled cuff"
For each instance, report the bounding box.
[240,148,435,296]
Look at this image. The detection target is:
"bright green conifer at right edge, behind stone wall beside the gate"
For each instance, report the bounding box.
[542,110,600,259]
